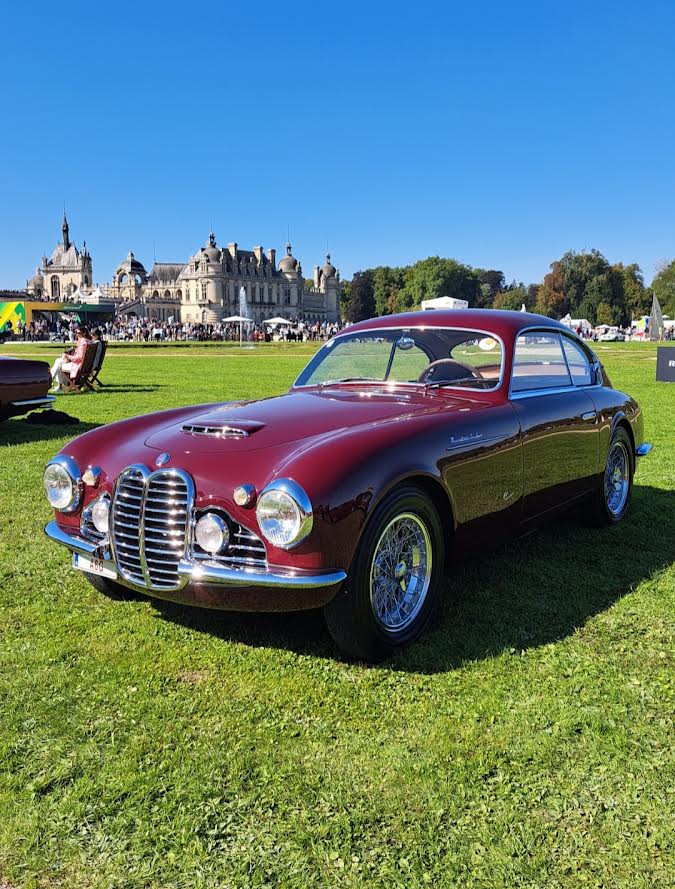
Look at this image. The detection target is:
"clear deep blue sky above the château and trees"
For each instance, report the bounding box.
[0,0,675,288]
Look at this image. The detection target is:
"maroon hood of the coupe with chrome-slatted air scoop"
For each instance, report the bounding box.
[145,387,476,456]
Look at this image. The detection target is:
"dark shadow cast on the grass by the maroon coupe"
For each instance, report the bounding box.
[149,487,675,673]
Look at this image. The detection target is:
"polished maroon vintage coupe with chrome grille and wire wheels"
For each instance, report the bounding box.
[44,309,650,660]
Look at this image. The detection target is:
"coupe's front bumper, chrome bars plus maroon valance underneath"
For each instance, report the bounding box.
[45,521,347,611]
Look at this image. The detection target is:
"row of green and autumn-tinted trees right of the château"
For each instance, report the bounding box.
[342,250,675,326]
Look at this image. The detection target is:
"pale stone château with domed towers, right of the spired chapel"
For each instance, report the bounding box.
[108,232,341,324]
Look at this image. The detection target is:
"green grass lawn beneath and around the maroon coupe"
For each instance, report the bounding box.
[0,344,675,889]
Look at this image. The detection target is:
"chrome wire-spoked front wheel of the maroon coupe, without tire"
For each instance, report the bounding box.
[370,513,432,634]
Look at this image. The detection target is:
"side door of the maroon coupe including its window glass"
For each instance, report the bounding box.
[510,329,599,522]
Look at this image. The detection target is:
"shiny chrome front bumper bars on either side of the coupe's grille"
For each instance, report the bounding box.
[45,521,347,592]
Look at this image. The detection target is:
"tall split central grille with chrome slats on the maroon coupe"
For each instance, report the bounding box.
[111,466,194,590]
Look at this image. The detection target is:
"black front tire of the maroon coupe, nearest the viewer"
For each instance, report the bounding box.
[324,485,444,662]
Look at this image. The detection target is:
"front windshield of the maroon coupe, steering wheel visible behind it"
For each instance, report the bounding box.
[295,327,503,389]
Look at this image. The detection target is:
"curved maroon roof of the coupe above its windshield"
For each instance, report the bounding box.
[342,309,569,338]
